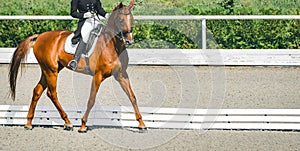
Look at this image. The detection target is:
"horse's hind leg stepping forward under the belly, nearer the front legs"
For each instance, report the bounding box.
[44,71,73,130]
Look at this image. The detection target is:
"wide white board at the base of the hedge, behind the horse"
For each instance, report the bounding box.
[0,48,300,66]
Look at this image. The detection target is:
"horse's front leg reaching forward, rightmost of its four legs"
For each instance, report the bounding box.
[115,71,146,129]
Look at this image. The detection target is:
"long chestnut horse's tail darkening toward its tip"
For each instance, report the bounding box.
[8,34,39,100]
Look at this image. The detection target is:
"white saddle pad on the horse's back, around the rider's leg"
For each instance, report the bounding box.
[64,33,98,57]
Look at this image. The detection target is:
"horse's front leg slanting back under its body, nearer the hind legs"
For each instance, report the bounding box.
[78,74,104,133]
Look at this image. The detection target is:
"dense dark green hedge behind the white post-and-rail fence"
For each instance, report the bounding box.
[0,0,300,49]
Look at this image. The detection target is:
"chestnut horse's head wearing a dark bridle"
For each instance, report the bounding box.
[108,0,134,45]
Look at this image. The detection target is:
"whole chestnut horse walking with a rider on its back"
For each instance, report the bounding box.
[9,0,146,132]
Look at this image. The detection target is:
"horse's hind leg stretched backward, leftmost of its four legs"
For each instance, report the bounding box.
[25,73,47,130]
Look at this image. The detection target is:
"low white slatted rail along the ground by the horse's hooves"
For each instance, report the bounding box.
[0,105,300,131]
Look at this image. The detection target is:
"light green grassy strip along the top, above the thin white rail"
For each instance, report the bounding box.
[0,0,300,15]
